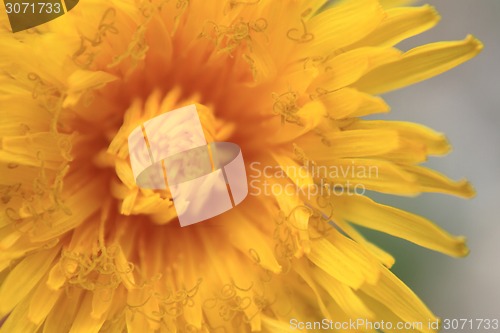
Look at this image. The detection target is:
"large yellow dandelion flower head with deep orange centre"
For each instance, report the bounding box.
[0,0,482,333]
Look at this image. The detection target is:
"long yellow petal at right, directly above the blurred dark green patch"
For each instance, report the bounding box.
[340,196,468,257]
